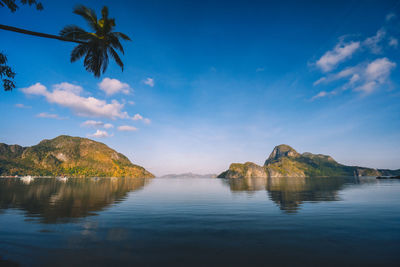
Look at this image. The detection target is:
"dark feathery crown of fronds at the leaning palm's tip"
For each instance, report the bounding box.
[60,5,131,77]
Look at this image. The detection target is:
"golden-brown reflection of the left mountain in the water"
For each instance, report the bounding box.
[0,178,150,223]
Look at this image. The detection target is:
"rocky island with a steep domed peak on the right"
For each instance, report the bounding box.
[218,145,400,178]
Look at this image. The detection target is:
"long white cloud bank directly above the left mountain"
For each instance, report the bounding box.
[22,83,129,119]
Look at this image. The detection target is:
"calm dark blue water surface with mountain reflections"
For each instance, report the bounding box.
[0,178,400,266]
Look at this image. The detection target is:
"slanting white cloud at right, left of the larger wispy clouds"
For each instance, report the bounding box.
[316,42,360,72]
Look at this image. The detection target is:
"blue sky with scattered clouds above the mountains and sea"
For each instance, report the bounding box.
[0,0,400,175]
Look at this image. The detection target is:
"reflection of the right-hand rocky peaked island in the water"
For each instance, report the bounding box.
[225,177,349,212]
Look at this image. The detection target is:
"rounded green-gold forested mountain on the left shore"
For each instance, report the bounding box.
[0,135,154,178]
